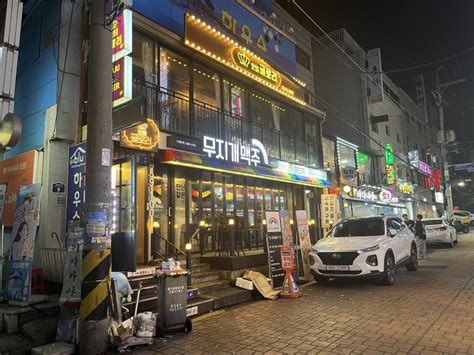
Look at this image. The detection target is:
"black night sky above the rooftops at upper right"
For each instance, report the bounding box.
[278,0,474,141]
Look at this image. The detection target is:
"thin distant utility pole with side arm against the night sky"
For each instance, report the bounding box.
[435,66,466,216]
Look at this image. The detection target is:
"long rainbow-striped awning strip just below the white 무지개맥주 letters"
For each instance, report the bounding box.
[160,150,332,187]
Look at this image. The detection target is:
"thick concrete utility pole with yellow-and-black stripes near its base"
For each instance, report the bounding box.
[79,0,113,354]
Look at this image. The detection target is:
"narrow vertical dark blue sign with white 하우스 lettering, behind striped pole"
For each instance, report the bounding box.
[66,142,87,231]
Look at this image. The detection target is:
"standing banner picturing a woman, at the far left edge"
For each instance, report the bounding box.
[4,184,41,302]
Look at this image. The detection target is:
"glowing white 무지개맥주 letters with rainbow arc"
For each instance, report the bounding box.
[203,136,269,166]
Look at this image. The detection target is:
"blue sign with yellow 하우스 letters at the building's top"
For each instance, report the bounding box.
[133,0,296,75]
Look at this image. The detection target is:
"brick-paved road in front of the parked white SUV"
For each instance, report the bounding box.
[140,233,474,354]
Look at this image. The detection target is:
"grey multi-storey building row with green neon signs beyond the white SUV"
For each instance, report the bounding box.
[313,29,442,221]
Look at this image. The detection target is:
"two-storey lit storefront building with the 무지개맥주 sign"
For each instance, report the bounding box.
[109,1,331,263]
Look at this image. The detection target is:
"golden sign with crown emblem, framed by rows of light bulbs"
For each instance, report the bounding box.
[184,14,306,106]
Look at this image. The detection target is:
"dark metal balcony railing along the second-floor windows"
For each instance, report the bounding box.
[133,80,320,166]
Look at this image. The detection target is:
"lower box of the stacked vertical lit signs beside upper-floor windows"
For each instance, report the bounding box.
[112,56,132,107]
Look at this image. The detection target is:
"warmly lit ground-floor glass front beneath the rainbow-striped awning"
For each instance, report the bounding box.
[112,155,317,264]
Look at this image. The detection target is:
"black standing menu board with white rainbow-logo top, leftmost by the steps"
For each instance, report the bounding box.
[265,211,285,287]
